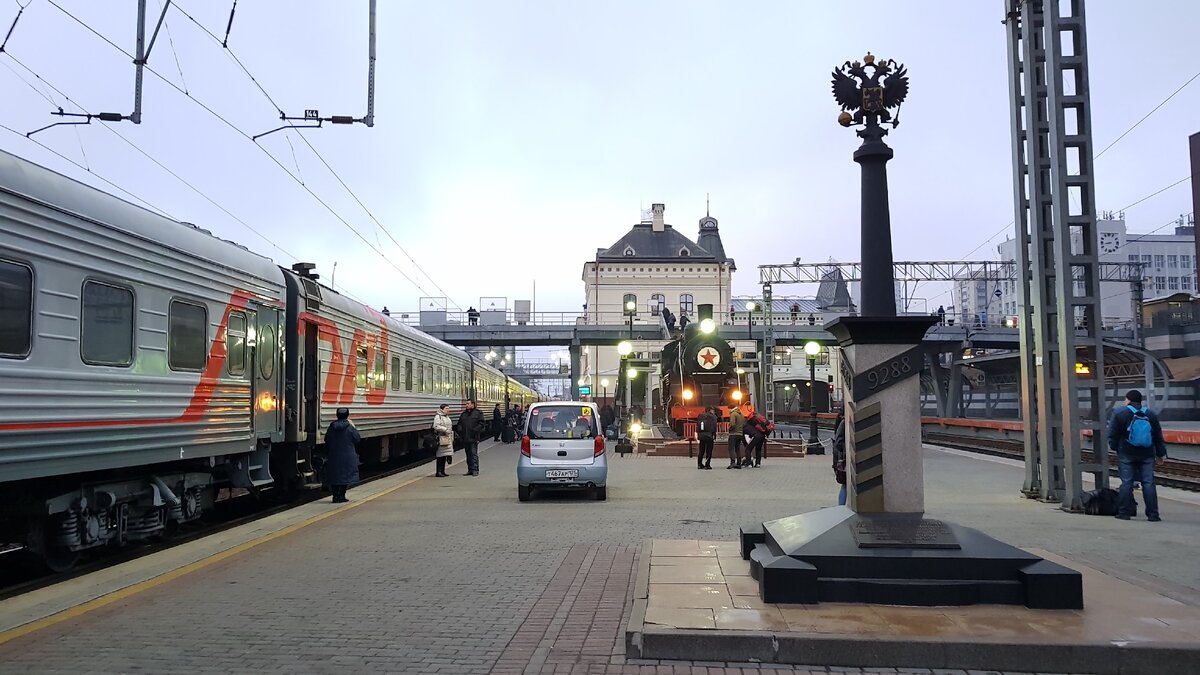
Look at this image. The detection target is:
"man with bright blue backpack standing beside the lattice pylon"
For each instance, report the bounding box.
[1109,389,1166,522]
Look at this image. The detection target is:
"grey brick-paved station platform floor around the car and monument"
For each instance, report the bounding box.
[0,443,1200,674]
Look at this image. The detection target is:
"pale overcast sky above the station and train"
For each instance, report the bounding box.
[0,0,1200,311]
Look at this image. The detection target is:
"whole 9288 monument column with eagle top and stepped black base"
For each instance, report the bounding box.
[742,54,1084,609]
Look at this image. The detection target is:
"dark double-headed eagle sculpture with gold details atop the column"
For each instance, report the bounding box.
[833,52,908,127]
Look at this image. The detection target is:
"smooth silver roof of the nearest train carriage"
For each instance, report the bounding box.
[0,150,282,283]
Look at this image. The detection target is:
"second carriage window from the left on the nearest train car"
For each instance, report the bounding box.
[79,281,133,366]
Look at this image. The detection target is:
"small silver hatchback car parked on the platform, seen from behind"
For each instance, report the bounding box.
[517,401,608,502]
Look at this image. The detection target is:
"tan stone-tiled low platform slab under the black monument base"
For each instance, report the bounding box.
[626,539,1200,675]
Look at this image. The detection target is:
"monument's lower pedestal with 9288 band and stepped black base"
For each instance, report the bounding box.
[742,317,1084,609]
